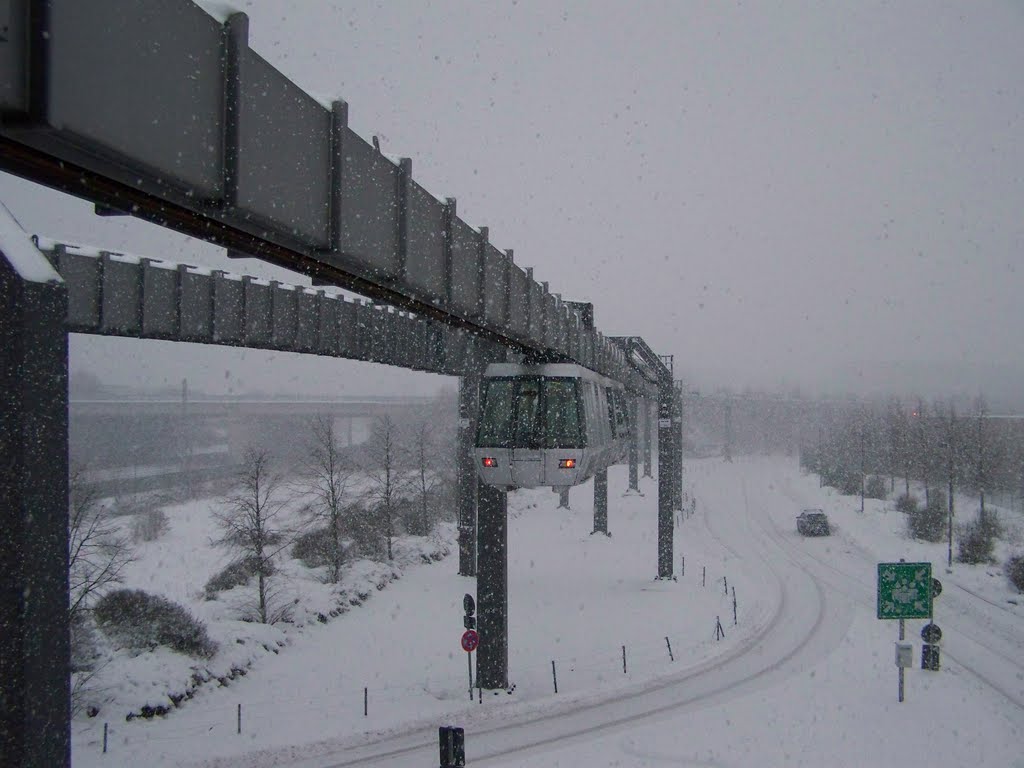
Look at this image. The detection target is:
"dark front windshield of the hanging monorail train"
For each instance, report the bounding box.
[476,376,586,450]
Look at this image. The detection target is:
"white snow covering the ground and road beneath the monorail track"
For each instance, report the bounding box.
[74,457,1024,768]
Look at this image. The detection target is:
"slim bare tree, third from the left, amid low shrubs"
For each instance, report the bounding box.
[307,415,352,584]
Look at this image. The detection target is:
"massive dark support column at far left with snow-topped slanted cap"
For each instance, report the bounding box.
[0,239,71,768]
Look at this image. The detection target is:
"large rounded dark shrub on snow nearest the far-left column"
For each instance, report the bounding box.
[93,590,217,658]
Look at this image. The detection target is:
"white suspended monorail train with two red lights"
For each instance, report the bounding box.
[475,362,629,489]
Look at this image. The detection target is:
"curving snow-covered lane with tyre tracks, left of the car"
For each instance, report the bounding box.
[286,460,850,768]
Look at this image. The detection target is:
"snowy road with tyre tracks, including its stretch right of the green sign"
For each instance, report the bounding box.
[282,462,1024,768]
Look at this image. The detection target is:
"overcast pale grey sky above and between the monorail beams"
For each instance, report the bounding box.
[0,0,1024,403]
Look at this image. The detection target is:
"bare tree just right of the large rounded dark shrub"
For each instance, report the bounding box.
[213,447,291,624]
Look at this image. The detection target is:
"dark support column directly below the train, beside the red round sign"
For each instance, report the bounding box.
[476,483,509,688]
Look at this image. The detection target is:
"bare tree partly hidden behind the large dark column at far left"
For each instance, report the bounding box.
[68,468,134,625]
